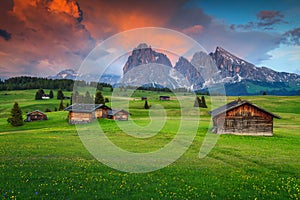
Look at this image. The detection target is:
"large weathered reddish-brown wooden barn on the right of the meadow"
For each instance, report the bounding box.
[210,98,280,136]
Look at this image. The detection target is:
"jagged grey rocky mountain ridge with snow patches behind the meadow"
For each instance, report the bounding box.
[123,44,300,89]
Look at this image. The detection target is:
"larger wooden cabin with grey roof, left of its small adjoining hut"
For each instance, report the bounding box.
[65,103,110,124]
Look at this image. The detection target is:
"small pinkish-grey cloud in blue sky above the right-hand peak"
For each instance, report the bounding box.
[230,10,287,30]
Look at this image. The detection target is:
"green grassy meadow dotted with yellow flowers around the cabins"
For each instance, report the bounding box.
[0,90,300,199]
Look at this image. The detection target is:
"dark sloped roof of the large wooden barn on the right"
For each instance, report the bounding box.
[209,100,280,119]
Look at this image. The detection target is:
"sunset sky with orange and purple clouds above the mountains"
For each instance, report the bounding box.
[0,0,300,78]
